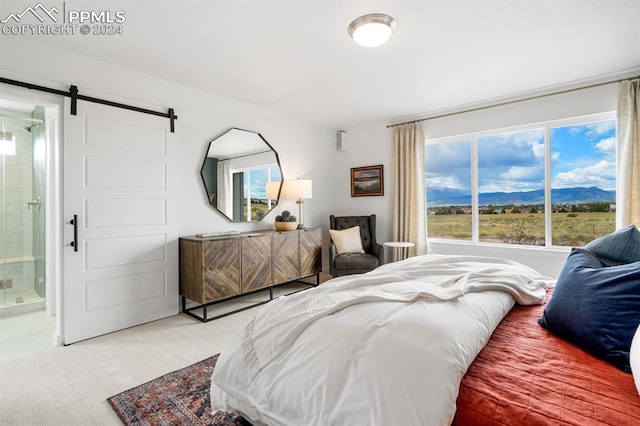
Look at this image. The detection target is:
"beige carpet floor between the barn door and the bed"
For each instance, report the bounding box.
[0,282,320,426]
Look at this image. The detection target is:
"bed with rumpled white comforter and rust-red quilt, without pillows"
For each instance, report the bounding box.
[211,251,640,425]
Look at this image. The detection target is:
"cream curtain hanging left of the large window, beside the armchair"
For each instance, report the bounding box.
[390,123,427,260]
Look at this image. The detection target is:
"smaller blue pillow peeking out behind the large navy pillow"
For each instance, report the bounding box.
[584,225,640,266]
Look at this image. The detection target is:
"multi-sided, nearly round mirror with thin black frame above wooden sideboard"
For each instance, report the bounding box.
[200,128,282,222]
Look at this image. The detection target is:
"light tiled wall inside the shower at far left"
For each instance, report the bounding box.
[0,123,35,302]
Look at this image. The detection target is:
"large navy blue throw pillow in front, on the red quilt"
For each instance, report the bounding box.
[538,248,640,372]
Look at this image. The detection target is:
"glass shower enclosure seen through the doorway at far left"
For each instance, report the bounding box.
[0,106,47,316]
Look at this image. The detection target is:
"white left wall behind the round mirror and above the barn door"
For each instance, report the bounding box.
[0,38,335,270]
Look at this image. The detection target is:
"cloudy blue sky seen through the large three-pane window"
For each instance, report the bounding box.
[425,120,616,193]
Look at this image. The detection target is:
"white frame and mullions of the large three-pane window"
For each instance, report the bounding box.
[425,110,619,249]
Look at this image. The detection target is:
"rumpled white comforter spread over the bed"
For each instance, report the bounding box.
[211,255,552,426]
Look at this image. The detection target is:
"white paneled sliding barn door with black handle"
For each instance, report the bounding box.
[64,99,179,344]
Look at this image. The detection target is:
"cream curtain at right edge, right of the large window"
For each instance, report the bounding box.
[616,79,640,227]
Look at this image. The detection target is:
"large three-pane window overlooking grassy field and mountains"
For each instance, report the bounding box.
[425,113,616,246]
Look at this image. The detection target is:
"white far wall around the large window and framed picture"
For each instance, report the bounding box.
[342,83,618,277]
